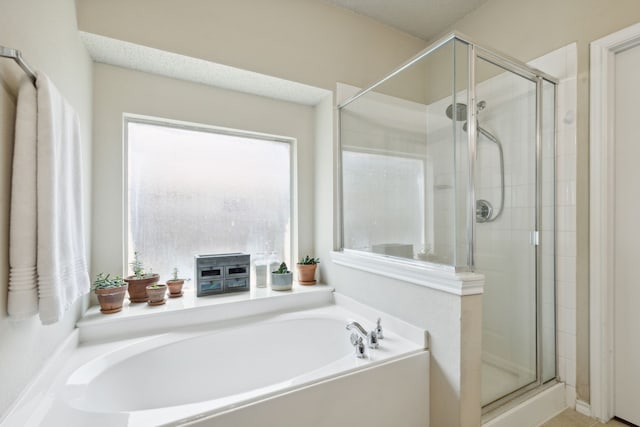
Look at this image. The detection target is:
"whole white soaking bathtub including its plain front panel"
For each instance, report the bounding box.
[3,290,429,427]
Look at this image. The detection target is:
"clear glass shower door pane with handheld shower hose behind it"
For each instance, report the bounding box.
[475,58,539,406]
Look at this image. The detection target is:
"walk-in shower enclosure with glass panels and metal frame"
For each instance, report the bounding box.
[338,34,557,411]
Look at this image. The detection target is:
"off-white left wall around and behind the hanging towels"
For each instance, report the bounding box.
[0,0,91,419]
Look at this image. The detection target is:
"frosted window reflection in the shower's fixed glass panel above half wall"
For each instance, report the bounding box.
[342,150,424,258]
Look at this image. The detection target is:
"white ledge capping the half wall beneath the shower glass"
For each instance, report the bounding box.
[331,251,484,296]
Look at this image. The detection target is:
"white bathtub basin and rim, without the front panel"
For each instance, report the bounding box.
[7,292,427,426]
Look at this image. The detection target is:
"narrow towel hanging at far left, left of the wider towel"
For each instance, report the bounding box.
[7,78,38,320]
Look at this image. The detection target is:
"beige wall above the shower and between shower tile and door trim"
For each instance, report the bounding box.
[451,0,640,401]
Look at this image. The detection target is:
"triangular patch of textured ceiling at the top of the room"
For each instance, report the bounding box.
[321,0,486,41]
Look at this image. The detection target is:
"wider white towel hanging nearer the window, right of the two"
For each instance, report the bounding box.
[36,73,89,325]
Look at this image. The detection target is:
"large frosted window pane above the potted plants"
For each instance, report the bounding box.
[127,120,291,280]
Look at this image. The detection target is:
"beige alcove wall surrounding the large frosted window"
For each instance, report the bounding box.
[92,64,314,274]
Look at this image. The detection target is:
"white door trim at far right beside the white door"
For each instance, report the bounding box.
[589,24,640,421]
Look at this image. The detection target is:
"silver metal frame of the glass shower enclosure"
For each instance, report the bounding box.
[335,32,559,415]
